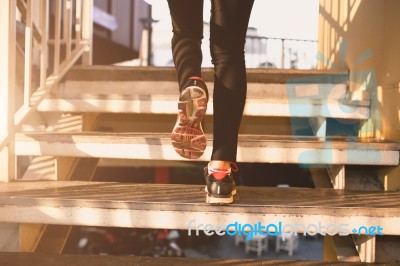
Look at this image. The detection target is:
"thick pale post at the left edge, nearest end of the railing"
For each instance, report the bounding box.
[0,0,16,182]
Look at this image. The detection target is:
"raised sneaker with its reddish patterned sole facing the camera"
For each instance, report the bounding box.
[171,77,208,159]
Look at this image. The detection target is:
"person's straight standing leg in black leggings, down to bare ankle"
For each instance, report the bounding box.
[210,0,254,164]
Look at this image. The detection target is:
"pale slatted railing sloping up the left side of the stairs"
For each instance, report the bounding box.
[0,0,93,181]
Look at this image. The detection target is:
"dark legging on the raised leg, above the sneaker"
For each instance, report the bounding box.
[168,0,203,90]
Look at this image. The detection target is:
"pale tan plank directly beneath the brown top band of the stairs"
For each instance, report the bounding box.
[56,80,350,99]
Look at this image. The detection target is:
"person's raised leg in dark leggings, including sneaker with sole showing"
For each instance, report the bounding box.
[168,0,208,159]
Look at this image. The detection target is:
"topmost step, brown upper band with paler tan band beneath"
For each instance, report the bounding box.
[57,66,349,99]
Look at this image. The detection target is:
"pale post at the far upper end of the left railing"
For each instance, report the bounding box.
[82,0,93,65]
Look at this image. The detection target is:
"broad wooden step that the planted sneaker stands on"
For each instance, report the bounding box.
[0,181,400,235]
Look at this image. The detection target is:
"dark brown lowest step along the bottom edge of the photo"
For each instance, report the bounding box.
[0,252,380,266]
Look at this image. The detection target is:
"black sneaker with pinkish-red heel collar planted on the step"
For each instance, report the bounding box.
[204,163,238,204]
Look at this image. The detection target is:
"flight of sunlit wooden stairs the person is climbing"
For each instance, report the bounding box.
[0,66,400,265]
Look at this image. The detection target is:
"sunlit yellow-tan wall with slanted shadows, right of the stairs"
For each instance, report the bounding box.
[318,0,400,190]
